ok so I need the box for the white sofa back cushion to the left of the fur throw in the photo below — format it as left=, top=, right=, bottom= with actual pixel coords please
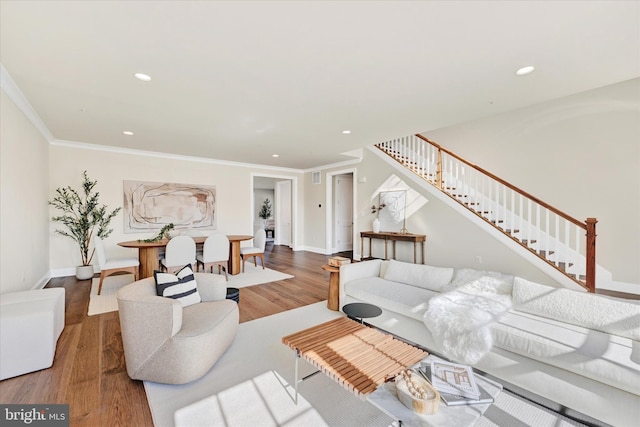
left=384, top=260, right=453, bottom=292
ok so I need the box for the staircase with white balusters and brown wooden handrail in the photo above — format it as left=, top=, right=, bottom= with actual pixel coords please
left=376, top=135, right=610, bottom=292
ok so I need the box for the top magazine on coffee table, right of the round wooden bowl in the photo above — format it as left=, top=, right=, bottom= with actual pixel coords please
left=428, top=360, right=481, bottom=400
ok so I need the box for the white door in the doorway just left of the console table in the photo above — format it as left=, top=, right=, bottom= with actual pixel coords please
left=333, top=174, right=353, bottom=252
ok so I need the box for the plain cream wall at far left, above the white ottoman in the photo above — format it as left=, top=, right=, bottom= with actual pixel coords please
left=0, top=90, right=49, bottom=293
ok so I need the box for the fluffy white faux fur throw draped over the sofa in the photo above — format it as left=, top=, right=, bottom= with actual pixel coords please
left=424, top=276, right=513, bottom=365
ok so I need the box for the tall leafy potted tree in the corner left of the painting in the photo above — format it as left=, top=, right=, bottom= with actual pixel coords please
left=49, top=171, right=121, bottom=280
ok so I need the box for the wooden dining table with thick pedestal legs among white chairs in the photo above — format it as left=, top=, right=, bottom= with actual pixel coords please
left=118, top=234, right=253, bottom=279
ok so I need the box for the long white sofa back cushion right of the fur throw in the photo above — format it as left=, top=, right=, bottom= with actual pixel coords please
left=513, top=277, right=640, bottom=341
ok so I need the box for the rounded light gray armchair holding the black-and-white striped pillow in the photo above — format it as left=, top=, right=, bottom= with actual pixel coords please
left=117, top=273, right=239, bottom=384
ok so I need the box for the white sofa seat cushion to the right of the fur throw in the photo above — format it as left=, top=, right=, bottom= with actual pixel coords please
left=491, top=310, right=640, bottom=395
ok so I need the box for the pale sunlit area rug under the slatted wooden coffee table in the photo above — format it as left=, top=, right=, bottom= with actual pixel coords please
left=144, top=301, right=582, bottom=427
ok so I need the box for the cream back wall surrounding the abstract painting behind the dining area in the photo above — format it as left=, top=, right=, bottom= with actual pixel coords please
left=48, top=144, right=302, bottom=276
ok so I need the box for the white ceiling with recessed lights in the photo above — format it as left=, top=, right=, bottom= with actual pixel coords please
left=0, top=0, right=640, bottom=169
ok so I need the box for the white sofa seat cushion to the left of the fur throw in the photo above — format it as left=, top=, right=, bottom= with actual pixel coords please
left=345, top=277, right=437, bottom=320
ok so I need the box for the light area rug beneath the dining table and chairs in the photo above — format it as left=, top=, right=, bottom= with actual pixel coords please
left=88, top=264, right=293, bottom=316
